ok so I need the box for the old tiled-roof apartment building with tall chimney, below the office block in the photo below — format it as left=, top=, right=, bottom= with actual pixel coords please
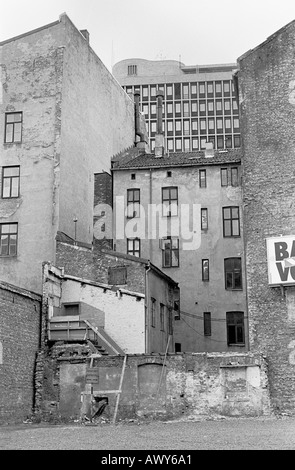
left=112, top=94, right=248, bottom=351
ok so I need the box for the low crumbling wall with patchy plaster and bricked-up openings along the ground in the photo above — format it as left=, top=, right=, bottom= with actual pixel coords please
left=37, top=346, right=271, bottom=420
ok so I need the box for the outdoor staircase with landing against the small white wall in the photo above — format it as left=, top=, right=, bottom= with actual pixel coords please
left=48, top=315, right=125, bottom=356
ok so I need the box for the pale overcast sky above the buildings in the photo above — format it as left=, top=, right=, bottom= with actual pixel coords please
left=0, top=0, right=295, bottom=70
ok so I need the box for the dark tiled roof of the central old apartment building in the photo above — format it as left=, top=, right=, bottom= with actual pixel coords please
left=112, top=149, right=242, bottom=171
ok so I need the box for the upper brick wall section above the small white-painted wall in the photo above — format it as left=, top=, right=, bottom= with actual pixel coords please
left=56, top=242, right=145, bottom=293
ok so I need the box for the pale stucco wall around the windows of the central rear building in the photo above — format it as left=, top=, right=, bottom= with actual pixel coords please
left=113, top=163, right=248, bottom=351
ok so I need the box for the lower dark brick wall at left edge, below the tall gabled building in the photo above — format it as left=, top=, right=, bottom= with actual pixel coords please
left=0, top=282, right=41, bottom=424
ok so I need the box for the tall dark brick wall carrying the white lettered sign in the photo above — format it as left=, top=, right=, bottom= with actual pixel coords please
left=238, top=21, right=295, bottom=414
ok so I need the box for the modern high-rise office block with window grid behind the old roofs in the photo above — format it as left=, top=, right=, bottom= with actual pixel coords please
left=113, top=59, right=240, bottom=152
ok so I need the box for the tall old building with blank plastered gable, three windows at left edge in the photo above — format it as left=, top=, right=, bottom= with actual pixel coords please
left=0, top=14, right=135, bottom=292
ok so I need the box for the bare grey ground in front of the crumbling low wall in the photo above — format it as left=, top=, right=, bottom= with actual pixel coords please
left=0, top=417, right=295, bottom=451
